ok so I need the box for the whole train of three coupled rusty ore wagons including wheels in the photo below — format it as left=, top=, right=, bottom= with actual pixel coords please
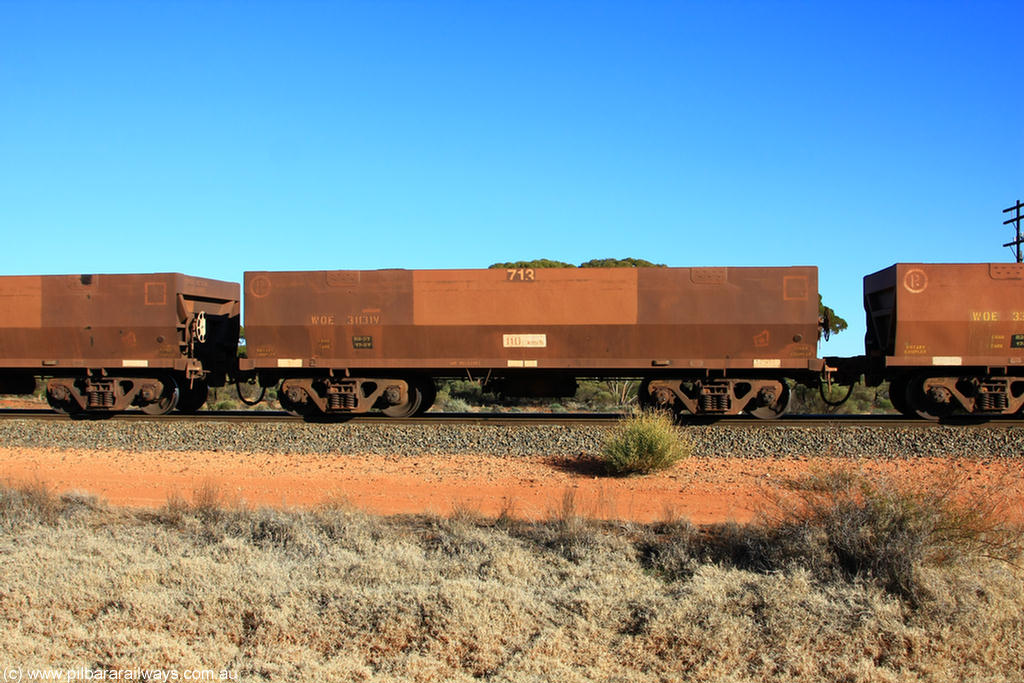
left=0, top=263, right=1024, bottom=419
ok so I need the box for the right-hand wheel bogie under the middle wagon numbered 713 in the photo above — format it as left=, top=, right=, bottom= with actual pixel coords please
left=642, top=378, right=790, bottom=420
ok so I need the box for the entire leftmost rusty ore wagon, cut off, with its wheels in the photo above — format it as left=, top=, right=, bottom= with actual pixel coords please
left=0, top=273, right=240, bottom=415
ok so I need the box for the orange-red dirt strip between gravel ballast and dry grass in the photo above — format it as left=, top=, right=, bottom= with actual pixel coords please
left=0, top=447, right=1024, bottom=523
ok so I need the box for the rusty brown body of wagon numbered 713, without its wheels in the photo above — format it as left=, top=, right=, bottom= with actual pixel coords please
left=245, top=266, right=820, bottom=374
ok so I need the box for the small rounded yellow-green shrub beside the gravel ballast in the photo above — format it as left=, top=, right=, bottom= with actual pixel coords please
left=601, top=411, right=693, bottom=475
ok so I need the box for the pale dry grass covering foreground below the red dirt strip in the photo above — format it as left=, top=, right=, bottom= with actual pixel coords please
left=0, top=473, right=1024, bottom=682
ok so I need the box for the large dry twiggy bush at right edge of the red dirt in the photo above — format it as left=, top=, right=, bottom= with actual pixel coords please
left=762, top=469, right=1022, bottom=604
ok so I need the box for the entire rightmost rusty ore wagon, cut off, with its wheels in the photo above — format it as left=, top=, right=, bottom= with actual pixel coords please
left=864, top=263, right=1024, bottom=418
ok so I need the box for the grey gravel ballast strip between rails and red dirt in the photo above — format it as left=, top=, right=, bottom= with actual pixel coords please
left=0, top=420, right=1024, bottom=458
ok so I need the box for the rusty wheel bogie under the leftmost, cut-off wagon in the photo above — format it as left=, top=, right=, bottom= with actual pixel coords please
left=46, top=372, right=179, bottom=415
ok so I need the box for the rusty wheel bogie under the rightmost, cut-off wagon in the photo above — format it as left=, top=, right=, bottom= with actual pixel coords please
left=906, top=375, right=1024, bottom=418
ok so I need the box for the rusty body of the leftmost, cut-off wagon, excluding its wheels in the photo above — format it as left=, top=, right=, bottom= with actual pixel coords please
left=0, top=273, right=240, bottom=374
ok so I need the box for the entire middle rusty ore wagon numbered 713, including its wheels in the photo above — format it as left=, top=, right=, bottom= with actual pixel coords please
left=242, top=267, right=822, bottom=418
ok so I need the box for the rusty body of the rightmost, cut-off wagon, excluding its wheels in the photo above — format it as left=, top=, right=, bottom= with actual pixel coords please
left=864, top=263, right=1024, bottom=369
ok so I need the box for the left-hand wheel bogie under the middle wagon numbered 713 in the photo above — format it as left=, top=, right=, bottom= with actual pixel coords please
left=278, top=377, right=421, bottom=417
